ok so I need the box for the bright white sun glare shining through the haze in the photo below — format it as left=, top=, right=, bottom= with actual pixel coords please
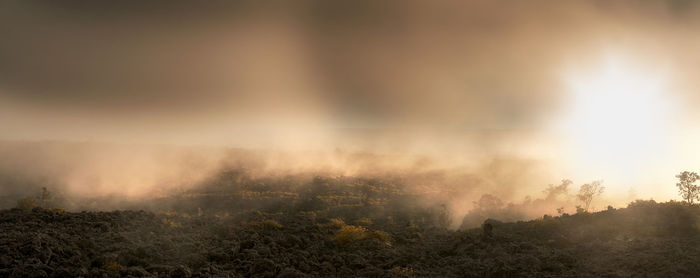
left=563, top=60, right=669, bottom=185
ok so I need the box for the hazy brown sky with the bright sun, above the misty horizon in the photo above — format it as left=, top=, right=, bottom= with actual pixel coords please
left=0, top=0, right=700, bottom=203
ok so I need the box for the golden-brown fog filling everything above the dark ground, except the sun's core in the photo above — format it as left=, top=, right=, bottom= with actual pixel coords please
left=0, top=0, right=700, bottom=213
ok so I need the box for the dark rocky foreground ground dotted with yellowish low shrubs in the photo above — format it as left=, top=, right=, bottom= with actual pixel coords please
left=0, top=204, right=700, bottom=277
